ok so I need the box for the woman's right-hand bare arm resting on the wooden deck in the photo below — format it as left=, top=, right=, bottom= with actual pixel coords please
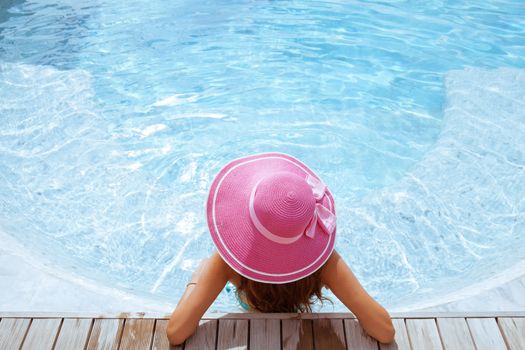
left=321, top=250, right=395, bottom=343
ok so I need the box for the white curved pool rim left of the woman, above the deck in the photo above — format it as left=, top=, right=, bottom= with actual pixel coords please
left=0, top=232, right=171, bottom=313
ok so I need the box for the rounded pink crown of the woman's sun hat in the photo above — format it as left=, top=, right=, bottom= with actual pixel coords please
left=253, top=172, right=315, bottom=238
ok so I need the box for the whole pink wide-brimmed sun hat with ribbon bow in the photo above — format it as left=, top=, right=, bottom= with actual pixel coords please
left=206, top=153, right=336, bottom=283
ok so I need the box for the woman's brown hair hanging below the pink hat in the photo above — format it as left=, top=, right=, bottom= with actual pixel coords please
left=237, top=268, right=331, bottom=312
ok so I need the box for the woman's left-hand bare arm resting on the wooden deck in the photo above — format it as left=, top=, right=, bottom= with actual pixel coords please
left=166, top=252, right=230, bottom=345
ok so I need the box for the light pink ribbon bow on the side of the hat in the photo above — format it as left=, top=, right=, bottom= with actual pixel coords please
left=304, top=175, right=336, bottom=238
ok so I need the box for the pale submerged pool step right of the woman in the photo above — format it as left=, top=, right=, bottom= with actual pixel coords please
left=344, top=68, right=525, bottom=306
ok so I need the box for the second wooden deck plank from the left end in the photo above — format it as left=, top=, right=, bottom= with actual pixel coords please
left=22, top=318, right=62, bottom=350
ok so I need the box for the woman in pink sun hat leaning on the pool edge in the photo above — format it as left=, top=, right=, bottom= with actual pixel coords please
left=167, top=153, right=394, bottom=345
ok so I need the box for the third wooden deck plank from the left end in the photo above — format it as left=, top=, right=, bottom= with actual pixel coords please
left=54, top=318, right=93, bottom=350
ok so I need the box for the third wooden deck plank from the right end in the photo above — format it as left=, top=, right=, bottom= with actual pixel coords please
left=437, top=318, right=476, bottom=350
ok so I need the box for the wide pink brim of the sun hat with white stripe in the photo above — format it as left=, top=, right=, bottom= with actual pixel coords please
left=206, top=153, right=335, bottom=283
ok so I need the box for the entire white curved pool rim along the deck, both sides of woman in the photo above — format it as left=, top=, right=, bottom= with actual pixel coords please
left=0, top=228, right=525, bottom=313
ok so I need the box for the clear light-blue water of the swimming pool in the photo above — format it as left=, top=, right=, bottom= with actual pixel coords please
left=0, top=0, right=525, bottom=309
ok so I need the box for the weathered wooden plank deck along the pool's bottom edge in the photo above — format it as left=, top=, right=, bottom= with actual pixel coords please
left=0, top=312, right=525, bottom=350
